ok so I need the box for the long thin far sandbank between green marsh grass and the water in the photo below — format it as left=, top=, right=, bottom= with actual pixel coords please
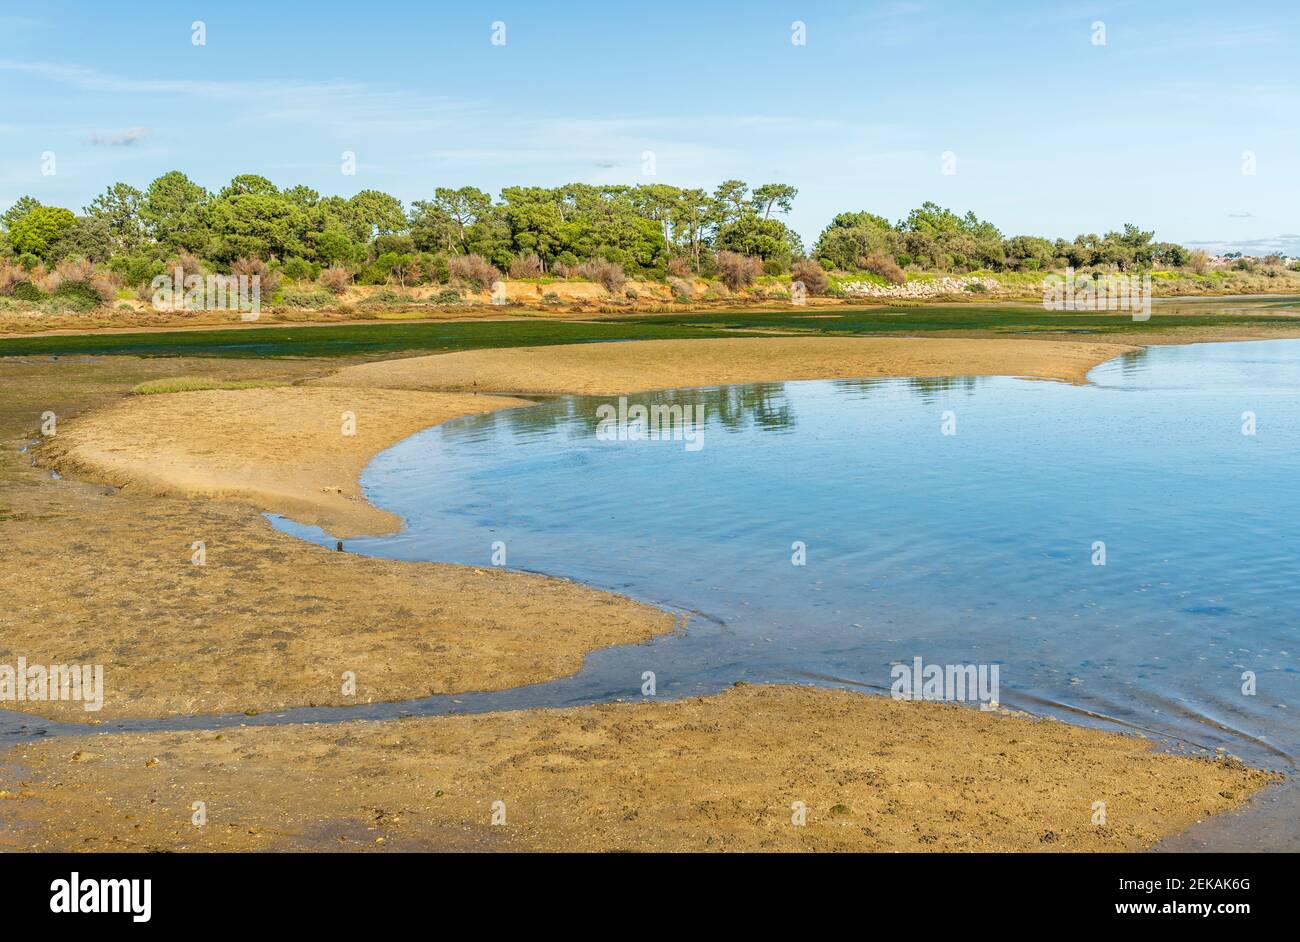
left=316, top=337, right=1136, bottom=395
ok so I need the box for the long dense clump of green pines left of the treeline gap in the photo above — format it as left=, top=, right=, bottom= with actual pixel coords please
left=0, top=172, right=802, bottom=296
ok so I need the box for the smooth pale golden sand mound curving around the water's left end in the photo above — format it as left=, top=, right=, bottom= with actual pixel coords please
left=46, top=386, right=530, bottom=537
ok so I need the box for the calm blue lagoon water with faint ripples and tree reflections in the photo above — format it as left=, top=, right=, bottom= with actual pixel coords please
left=280, top=340, right=1300, bottom=768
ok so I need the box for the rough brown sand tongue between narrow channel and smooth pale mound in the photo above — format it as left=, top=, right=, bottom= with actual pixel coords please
left=0, top=491, right=676, bottom=722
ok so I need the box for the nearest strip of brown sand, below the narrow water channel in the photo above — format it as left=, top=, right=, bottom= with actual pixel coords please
left=0, top=686, right=1269, bottom=851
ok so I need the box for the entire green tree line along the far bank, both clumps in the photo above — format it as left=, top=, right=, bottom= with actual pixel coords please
left=0, top=172, right=1195, bottom=283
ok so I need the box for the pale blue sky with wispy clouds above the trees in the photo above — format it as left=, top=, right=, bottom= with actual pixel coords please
left=0, top=0, right=1300, bottom=253
